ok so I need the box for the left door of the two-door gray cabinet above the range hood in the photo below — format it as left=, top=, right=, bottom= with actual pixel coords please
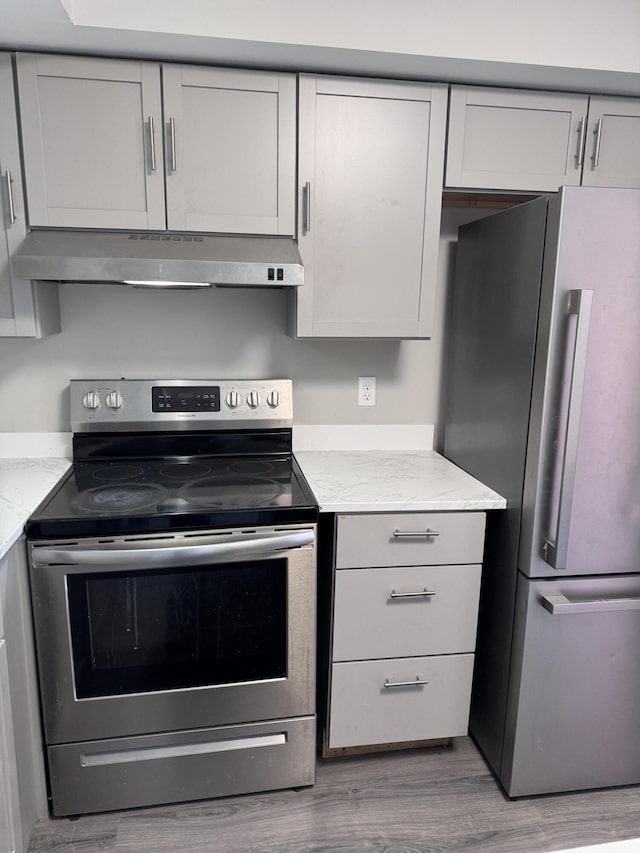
left=17, top=54, right=165, bottom=230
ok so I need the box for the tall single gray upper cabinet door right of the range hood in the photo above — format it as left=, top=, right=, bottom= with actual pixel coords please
left=295, top=75, right=446, bottom=338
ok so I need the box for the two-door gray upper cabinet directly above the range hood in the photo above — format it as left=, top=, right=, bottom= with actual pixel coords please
left=17, top=53, right=296, bottom=235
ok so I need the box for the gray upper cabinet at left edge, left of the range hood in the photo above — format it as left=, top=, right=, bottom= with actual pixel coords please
left=0, top=54, right=60, bottom=338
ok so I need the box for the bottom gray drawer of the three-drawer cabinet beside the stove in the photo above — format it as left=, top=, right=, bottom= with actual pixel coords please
left=329, top=655, right=473, bottom=748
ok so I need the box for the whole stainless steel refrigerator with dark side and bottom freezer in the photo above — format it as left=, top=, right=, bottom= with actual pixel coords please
left=444, top=187, right=640, bottom=797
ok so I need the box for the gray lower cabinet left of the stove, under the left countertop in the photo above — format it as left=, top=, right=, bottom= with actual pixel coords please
left=0, top=540, right=47, bottom=853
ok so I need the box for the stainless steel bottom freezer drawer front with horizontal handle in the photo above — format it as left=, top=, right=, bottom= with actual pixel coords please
left=501, top=575, right=640, bottom=797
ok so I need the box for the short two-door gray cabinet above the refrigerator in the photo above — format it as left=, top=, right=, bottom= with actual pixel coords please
left=445, top=86, right=640, bottom=192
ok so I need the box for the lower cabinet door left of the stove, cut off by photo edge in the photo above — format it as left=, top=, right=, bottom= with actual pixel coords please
left=0, top=640, right=19, bottom=853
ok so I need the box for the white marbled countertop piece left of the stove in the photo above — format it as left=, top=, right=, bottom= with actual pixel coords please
left=0, top=458, right=71, bottom=559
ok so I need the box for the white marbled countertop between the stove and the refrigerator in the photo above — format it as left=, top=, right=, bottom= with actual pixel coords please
left=295, top=450, right=507, bottom=513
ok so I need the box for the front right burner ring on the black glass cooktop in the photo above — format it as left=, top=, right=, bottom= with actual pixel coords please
left=180, top=474, right=284, bottom=510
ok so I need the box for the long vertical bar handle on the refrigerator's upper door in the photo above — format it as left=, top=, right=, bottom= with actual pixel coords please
left=543, top=290, right=593, bottom=570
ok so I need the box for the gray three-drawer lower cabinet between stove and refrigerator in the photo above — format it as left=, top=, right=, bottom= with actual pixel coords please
left=326, top=512, right=485, bottom=749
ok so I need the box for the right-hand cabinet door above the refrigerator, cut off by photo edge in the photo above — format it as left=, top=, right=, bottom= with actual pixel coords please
left=582, top=98, right=640, bottom=187
